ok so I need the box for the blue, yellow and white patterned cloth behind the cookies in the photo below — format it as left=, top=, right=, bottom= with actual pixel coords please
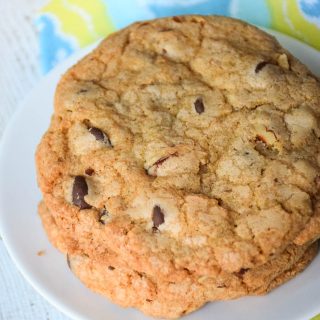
left=36, top=0, right=320, bottom=72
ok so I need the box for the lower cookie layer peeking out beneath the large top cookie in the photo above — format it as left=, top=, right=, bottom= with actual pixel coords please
left=39, top=203, right=317, bottom=318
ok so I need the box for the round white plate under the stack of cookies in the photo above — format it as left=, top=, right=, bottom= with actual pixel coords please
left=0, top=31, right=320, bottom=320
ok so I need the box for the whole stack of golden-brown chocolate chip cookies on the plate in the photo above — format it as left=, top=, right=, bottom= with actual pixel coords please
left=36, top=16, right=320, bottom=318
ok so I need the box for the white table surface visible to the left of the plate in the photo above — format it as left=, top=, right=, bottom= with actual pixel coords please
left=0, top=0, right=68, bottom=320
